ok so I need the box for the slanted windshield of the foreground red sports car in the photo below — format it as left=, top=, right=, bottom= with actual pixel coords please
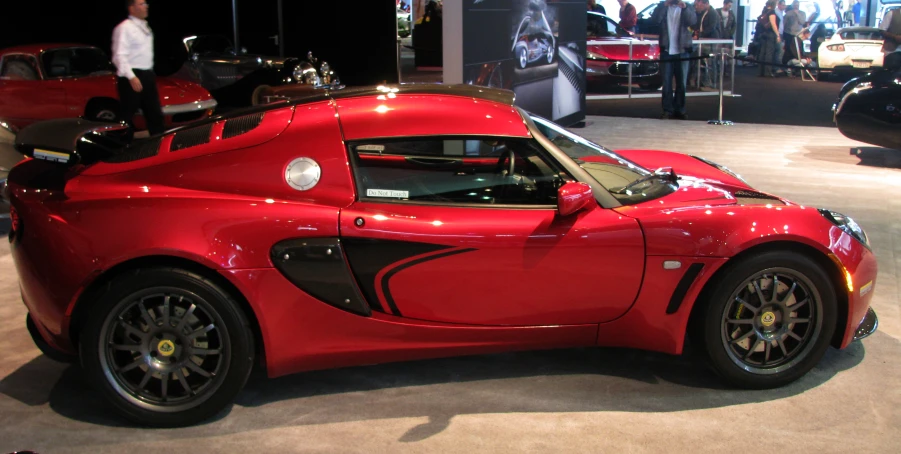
left=531, top=116, right=676, bottom=205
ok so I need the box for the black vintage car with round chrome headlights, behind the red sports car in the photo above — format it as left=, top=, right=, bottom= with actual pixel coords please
left=172, top=35, right=343, bottom=108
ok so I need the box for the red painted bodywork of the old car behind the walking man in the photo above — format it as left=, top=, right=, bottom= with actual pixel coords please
left=0, top=43, right=213, bottom=129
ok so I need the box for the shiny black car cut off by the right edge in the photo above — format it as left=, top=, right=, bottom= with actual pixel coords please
left=833, top=63, right=901, bottom=151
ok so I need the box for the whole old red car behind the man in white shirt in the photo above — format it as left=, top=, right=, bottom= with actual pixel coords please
left=0, top=44, right=216, bottom=128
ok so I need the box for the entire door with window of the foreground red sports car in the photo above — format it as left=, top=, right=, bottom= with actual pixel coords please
left=340, top=137, right=644, bottom=325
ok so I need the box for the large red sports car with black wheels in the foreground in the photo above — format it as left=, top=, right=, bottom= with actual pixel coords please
left=7, top=85, right=877, bottom=425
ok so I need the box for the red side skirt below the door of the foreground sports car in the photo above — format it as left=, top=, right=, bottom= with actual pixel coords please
left=223, top=269, right=598, bottom=377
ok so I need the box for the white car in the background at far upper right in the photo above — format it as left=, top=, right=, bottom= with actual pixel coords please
left=817, top=27, right=882, bottom=76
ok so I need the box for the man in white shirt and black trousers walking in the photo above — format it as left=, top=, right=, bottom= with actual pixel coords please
left=113, top=0, right=165, bottom=141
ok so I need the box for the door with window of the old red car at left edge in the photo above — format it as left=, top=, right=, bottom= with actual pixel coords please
left=0, top=54, right=67, bottom=126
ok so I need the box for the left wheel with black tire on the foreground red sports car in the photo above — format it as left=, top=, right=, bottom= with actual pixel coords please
left=79, top=268, right=254, bottom=427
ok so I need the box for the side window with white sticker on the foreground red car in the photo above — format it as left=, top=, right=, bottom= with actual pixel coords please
left=348, top=137, right=568, bottom=205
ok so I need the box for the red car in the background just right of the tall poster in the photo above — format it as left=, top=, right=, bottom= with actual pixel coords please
left=585, top=11, right=663, bottom=91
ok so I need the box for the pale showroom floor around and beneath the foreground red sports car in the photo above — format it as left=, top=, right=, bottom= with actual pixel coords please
left=0, top=117, right=901, bottom=453
